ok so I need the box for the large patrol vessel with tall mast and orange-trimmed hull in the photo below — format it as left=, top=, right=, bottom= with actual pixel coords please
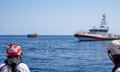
left=74, top=14, right=120, bottom=41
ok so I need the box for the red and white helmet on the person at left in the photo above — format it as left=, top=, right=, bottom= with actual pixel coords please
left=7, top=44, right=22, bottom=56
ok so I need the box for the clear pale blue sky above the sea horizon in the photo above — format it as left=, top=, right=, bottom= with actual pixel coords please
left=0, top=0, right=120, bottom=35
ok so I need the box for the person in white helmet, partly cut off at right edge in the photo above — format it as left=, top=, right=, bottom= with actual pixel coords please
left=107, top=40, right=120, bottom=72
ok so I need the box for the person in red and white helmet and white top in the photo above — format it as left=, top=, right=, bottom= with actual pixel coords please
left=0, top=44, right=30, bottom=72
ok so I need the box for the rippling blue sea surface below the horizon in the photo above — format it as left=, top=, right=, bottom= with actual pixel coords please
left=0, top=35, right=113, bottom=72
